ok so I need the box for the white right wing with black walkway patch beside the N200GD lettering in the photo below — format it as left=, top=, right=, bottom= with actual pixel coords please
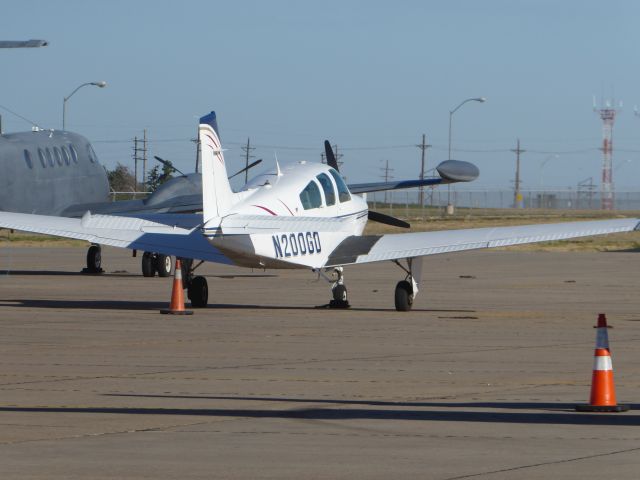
left=325, top=218, right=640, bottom=267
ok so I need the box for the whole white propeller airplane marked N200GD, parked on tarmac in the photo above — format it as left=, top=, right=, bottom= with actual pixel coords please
left=0, top=111, right=640, bottom=311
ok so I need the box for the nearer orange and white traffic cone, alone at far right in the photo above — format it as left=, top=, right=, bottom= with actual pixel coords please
left=576, top=313, right=629, bottom=412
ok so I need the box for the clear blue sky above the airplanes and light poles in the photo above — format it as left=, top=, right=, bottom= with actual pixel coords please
left=0, top=0, right=640, bottom=189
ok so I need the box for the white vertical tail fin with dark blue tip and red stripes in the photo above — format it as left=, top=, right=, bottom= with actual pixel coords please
left=198, top=112, right=233, bottom=223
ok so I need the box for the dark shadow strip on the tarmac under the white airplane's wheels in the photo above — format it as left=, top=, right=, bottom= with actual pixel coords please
left=0, top=298, right=475, bottom=318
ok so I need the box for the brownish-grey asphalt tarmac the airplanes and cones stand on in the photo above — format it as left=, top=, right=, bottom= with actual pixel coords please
left=0, top=247, right=640, bottom=480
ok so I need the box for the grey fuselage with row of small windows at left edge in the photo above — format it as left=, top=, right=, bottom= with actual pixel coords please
left=0, top=130, right=109, bottom=215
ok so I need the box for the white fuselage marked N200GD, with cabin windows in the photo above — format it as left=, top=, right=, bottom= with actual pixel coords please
left=205, top=162, right=368, bottom=268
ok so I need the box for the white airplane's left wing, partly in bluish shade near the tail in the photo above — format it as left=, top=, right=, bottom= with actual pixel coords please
left=0, top=212, right=231, bottom=264
